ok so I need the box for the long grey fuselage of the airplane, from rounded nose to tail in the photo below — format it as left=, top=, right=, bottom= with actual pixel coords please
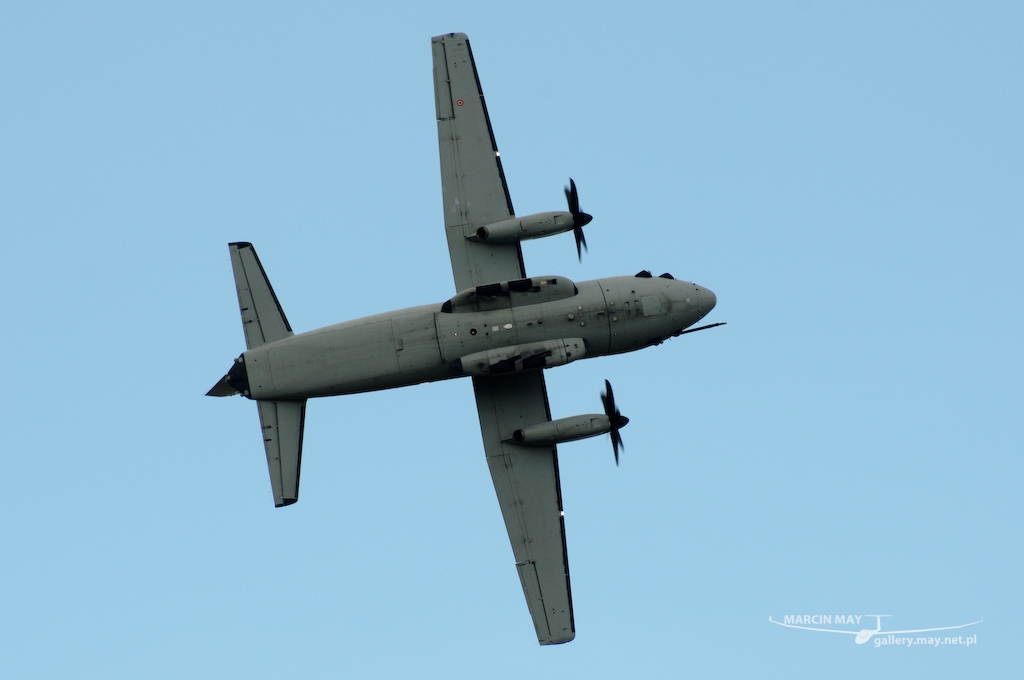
left=242, top=277, right=716, bottom=400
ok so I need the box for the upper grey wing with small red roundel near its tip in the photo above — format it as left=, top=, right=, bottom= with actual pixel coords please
left=431, top=33, right=526, bottom=292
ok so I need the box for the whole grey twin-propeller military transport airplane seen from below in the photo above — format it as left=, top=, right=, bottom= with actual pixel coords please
left=209, top=33, right=720, bottom=644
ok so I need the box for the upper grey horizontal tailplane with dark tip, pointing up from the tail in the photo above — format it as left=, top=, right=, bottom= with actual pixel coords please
left=227, top=242, right=295, bottom=349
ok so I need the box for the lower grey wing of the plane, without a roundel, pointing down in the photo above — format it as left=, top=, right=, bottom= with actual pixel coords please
left=473, top=371, right=575, bottom=644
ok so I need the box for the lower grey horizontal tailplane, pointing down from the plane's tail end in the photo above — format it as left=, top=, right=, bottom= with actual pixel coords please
left=256, top=399, right=306, bottom=508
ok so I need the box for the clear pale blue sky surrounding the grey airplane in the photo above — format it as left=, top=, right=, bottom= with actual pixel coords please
left=0, top=0, right=1024, bottom=678
